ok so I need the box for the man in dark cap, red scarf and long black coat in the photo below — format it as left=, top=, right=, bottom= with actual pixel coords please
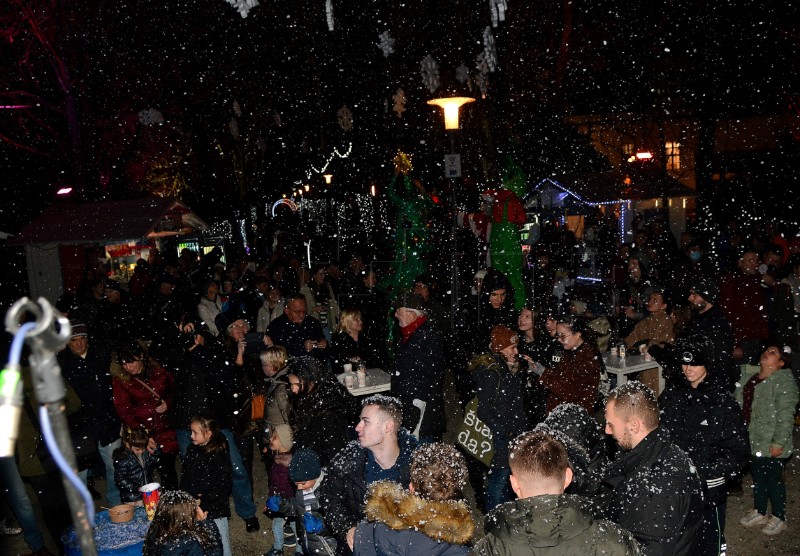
left=392, top=293, right=447, bottom=442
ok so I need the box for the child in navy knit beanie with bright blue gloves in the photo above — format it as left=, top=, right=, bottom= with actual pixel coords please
left=267, top=448, right=336, bottom=555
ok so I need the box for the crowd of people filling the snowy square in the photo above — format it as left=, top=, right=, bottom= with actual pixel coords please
left=0, top=216, right=800, bottom=556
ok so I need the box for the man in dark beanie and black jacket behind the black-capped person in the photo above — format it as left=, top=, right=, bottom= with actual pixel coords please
left=683, top=276, right=739, bottom=392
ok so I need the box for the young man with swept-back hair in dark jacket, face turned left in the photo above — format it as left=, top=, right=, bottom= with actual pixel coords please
left=320, top=394, right=417, bottom=552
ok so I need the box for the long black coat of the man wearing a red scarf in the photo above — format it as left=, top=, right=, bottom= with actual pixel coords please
left=392, top=320, right=447, bottom=438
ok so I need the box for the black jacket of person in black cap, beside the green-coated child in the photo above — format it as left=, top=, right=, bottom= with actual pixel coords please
left=658, top=379, right=750, bottom=506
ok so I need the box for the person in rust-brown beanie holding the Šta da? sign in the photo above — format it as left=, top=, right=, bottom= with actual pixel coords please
left=470, top=325, right=528, bottom=512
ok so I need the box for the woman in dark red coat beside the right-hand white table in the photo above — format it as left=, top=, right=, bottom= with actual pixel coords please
left=541, top=317, right=603, bottom=415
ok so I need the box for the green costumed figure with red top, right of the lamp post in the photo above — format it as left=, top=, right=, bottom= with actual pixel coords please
left=484, top=157, right=527, bottom=310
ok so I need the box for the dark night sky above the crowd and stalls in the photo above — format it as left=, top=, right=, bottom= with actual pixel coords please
left=0, top=0, right=800, bottom=233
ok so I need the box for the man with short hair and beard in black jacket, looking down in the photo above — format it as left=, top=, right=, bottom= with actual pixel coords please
left=604, top=382, right=703, bottom=556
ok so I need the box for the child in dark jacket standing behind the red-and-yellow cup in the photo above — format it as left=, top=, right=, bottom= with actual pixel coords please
left=113, top=427, right=161, bottom=506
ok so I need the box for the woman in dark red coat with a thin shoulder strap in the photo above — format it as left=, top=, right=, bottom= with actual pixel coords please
left=112, top=343, right=178, bottom=489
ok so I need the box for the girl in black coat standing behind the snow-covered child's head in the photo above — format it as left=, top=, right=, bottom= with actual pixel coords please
left=181, top=415, right=232, bottom=556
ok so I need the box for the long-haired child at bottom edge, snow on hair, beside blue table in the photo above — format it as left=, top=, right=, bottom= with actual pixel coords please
left=142, top=490, right=222, bottom=556
